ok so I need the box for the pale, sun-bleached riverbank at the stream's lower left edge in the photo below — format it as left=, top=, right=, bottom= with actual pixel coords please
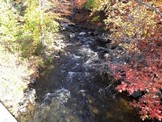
left=0, top=49, right=34, bottom=116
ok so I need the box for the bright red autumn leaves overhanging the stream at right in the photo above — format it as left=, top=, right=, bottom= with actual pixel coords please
left=110, top=35, right=162, bottom=121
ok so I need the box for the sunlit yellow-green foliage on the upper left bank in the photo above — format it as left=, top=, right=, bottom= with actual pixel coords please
left=0, top=0, right=59, bottom=57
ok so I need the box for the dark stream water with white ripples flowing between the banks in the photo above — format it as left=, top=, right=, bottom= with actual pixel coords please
left=18, top=24, right=141, bottom=122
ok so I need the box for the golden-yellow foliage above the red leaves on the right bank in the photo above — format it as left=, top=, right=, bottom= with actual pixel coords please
left=90, top=0, right=156, bottom=49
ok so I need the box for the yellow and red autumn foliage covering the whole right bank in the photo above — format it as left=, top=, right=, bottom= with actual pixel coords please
left=83, top=0, right=162, bottom=121
